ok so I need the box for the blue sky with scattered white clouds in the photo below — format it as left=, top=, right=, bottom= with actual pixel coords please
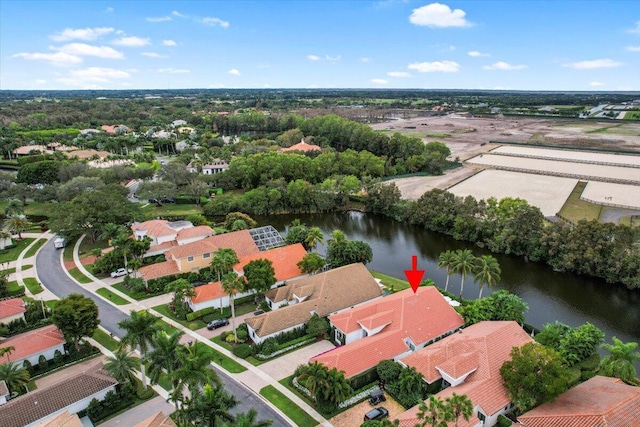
left=0, top=0, right=640, bottom=91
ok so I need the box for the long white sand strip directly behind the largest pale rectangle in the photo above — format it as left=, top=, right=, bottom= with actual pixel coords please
left=467, top=154, right=640, bottom=184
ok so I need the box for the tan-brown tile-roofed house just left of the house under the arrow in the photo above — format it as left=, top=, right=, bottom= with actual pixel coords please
left=246, top=263, right=382, bottom=343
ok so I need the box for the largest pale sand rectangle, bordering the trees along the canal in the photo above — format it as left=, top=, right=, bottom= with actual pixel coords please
left=449, top=170, right=578, bottom=216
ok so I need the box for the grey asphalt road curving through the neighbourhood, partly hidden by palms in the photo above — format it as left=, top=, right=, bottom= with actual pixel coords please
left=35, top=239, right=290, bottom=427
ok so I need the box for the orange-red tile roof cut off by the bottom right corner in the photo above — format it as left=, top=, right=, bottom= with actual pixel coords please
left=518, top=376, right=640, bottom=427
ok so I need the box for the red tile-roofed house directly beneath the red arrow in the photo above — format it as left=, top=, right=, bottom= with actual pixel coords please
left=310, top=286, right=464, bottom=378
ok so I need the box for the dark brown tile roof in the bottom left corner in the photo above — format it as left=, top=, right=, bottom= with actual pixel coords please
left=0, top=363, right=118, bottom=427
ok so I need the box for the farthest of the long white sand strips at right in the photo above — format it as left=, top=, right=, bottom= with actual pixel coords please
left=491, top=145, right=640, bottom=167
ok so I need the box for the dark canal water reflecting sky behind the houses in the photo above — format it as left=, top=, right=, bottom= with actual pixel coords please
left=256, top=212, right=640, bottom=352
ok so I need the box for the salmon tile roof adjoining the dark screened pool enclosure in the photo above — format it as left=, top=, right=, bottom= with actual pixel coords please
left=166, top=230, right=260, bottom=259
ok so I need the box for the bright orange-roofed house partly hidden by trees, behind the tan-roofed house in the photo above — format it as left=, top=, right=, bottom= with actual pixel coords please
left=188, top=243, right=307, bottom=311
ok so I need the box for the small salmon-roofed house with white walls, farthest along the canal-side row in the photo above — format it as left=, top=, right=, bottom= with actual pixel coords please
left=131, top=219, right=215, bottom=257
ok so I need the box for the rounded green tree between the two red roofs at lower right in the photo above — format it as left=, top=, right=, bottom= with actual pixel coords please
left=500, top=343, right=570, bottom=412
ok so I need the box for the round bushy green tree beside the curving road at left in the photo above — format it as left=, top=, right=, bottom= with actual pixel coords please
left=51, top=293, right=100, bottom=350
